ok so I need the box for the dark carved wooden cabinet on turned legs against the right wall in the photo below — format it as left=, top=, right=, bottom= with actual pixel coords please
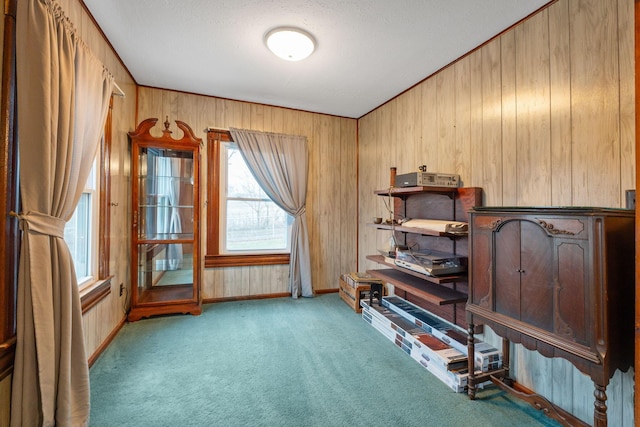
left=467, top=207, right=635, bottom=426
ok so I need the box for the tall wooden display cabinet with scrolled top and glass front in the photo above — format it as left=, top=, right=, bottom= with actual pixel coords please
left=128, top=118, right=202, bottom=321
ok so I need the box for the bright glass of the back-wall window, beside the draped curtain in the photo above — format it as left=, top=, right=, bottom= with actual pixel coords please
left=220, top=143, right=293, bottom=253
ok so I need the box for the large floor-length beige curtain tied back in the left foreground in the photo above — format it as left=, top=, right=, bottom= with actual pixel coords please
left=11, top=0, right=113, bottom=426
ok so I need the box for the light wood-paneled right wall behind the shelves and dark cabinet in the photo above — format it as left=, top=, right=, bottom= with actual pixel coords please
left=358, top=0, right=635, bottom=426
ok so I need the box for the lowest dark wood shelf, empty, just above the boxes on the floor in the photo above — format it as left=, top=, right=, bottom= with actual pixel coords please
left=367, top=268, right=467, bottom=305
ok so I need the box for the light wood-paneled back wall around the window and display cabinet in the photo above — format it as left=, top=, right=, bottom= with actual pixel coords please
left=137, top=87, right=357, bottom=302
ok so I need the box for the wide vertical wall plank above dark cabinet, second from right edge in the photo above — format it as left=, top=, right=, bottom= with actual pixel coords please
left=569, top=0, right=621, bottom=206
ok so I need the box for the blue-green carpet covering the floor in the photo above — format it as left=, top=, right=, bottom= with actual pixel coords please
left=90, top=294, right=558, bottom=427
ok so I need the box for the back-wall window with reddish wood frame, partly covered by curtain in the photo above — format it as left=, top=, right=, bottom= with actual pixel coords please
left=205, top=130, right=293, bottom=267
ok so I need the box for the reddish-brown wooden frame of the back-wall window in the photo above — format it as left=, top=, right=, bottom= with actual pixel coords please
left=204, top=128, right=290, bottom=268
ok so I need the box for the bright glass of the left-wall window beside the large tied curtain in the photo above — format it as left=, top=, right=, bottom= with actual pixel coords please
left=64, top=193, right=91, bottom=283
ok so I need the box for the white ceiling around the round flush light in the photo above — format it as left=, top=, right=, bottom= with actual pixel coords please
left=84, top=0, right=549, bottom=118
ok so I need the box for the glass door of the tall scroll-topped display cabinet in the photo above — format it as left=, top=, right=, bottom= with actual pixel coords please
left=137, top=147, right=194, bottom=303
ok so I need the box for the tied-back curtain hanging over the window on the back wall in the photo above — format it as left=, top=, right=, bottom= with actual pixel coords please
left=229, top=128, right=313, bottom=298
